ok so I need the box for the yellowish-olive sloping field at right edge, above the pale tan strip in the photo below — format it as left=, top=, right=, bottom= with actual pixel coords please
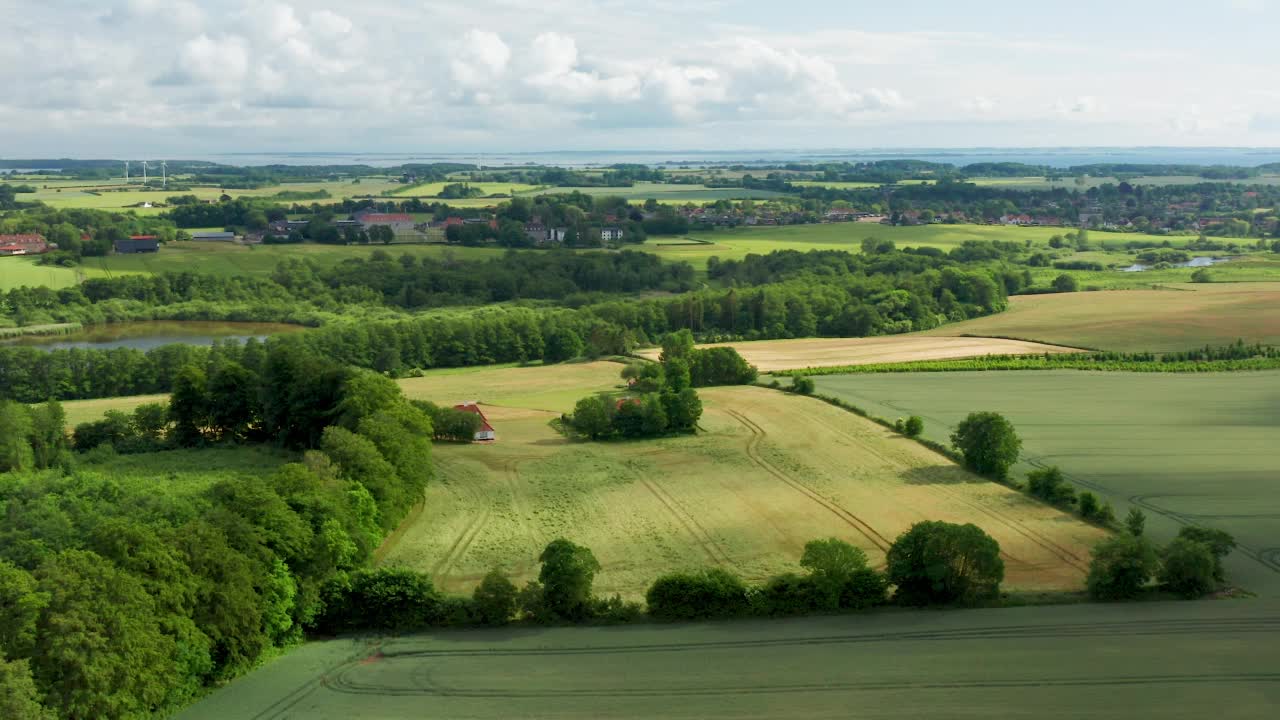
left=925, top=282, right=1280, bottom=352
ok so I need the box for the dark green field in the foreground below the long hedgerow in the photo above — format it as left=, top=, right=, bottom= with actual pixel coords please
left=178, top=601, right=1280, bottom=720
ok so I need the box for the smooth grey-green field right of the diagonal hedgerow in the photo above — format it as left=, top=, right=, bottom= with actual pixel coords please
left=815, top=370, right=1280, bottom=596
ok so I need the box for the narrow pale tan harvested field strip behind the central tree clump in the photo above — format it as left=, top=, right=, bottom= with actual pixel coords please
left=636, top=335, right=1075, bottom=373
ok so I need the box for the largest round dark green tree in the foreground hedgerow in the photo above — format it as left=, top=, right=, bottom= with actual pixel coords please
left=887, top=521, right=1005, bottom=605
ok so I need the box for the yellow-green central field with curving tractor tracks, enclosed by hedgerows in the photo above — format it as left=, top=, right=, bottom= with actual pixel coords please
left=379, top=384, right=1105, bottom=598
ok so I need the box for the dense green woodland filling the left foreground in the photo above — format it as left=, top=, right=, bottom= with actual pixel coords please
left=0, top=347, right=431, bottom=717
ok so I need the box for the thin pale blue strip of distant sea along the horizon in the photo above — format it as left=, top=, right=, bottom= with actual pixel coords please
left=202, top=147, right=1280, bottom=168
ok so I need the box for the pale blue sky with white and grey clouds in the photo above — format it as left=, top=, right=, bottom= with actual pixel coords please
left=0, top=0, right=1280, bottom=158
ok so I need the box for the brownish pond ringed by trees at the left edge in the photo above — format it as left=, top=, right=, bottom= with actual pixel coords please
left=0, top=320, right=306, bottom=351
